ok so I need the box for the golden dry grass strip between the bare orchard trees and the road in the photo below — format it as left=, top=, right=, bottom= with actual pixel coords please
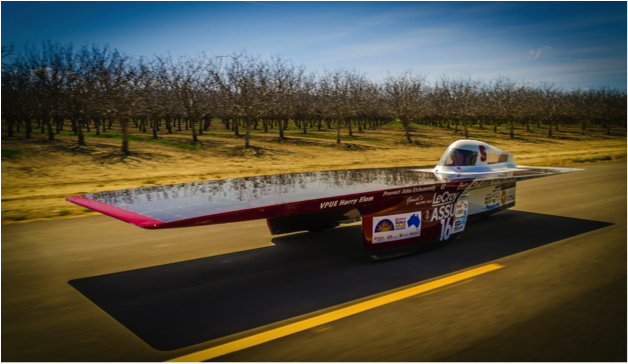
left=2, top=122, right=628, bottom=224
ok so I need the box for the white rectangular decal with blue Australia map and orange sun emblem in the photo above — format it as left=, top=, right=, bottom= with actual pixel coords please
left=373, top=212, right=421, bottom=244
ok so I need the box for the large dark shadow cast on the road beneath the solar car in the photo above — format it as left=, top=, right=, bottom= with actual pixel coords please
left=69, top=211, right=612, bottom=350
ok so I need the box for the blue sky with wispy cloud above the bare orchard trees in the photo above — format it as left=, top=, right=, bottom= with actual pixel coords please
left=1, top=1, right=628, bottom=91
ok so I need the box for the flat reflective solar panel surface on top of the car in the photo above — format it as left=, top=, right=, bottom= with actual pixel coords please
left=77, top=167, right=576, bottom=223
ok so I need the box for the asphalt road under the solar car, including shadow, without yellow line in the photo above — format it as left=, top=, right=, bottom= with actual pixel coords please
left=1, top=162, right=628, bottom=362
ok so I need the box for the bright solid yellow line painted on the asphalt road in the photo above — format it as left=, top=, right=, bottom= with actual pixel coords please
left=165, top=264, right=504, bottom=363
